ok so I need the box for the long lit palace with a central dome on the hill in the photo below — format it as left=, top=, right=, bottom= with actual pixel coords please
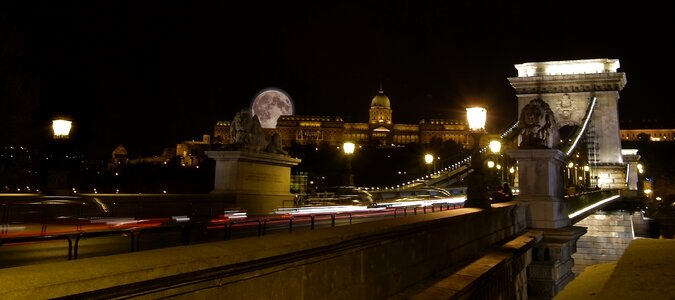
left=214, top=89, right=471, bottom=146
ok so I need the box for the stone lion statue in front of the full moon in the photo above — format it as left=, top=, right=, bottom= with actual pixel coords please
left=230, top=108, right=288, bottom=154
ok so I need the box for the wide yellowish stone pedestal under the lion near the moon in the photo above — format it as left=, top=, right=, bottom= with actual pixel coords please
left=205, top=151, right=300, bottom=215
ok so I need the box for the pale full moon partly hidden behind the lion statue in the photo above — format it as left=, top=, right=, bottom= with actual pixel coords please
left=251, top=89, right=293, bottom=128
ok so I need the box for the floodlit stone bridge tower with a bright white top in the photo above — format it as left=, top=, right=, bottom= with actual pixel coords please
left=508, top=58, right=626, bottom=188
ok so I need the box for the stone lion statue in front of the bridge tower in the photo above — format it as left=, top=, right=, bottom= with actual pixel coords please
left=518, top=98, right=560, bottom=149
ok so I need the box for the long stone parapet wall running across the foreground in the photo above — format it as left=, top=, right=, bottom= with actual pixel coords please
left=0, top=203, right=529, bottom=300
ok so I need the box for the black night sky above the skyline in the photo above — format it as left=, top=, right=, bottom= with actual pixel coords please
left=0, top=0, right=675, bottom=157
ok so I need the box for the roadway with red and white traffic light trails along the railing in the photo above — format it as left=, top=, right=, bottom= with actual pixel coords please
left=0, top=197, right=464, bottom=268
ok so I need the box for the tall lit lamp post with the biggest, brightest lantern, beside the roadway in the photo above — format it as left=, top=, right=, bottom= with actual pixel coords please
left=464, top=107, right=490, bottom=209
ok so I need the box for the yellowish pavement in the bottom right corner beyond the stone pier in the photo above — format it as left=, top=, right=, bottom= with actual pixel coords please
left=553, top=238, right=675, bottom=300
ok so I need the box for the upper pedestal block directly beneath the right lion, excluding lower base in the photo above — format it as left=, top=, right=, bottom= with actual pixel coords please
left=508, top=149, right=571, bottom=229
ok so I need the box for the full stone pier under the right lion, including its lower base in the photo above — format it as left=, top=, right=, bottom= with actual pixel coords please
left=508, top=149, right=586, bottom=299
